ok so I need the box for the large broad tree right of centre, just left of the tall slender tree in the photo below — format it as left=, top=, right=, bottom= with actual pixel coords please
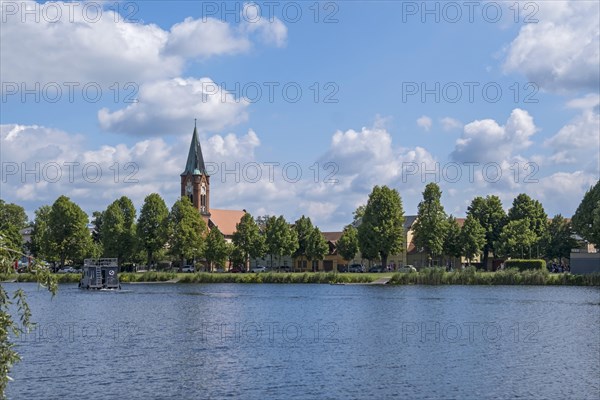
left=358, top=186, right=404, bottom=266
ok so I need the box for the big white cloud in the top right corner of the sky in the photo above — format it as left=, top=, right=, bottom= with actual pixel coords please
left=504, top=1, right=600, bottom=92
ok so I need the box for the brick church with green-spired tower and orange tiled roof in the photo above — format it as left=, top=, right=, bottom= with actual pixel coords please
left=181, top=126, right=246, bottom=242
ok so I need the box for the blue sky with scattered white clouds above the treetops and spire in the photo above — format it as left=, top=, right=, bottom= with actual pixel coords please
left=0, top=0, right=600, bottom=231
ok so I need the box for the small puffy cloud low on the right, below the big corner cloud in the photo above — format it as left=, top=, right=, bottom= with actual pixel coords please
left=450, top=108, right=537, bottom=163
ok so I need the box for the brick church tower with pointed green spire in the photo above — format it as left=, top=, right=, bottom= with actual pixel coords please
left=181, top=123, right=210, bottom=221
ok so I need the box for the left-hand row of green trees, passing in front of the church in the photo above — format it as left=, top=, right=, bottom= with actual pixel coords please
left=0, top=193, right=329, bottom=269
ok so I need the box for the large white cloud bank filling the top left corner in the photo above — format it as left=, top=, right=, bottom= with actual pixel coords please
left=0, top=1, right=287, bottom=86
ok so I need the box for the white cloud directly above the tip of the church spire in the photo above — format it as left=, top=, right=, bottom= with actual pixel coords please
left=98, top=78, right=249, bottom=135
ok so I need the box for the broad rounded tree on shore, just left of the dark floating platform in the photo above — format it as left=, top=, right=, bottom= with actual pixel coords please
left=46, top=196, right=92, bottom=266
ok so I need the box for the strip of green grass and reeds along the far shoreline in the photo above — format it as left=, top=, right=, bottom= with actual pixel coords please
left=0, top=268, right=600, bottom=286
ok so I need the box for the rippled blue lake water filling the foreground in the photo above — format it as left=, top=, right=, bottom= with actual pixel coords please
left=5, top=284, right=600, bottom=399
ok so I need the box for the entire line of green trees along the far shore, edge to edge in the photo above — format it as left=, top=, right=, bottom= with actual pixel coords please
left=0, top=183, right=600, bottom=266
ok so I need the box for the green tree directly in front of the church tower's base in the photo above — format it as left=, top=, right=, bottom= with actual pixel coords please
left=168, top=196, right=207, bottom=266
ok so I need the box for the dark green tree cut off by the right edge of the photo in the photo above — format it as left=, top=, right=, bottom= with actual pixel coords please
left=572, top=181, right=600, bottom=247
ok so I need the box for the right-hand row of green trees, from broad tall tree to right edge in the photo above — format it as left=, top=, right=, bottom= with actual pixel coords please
left=338, top=183, right=600, bottom=266
